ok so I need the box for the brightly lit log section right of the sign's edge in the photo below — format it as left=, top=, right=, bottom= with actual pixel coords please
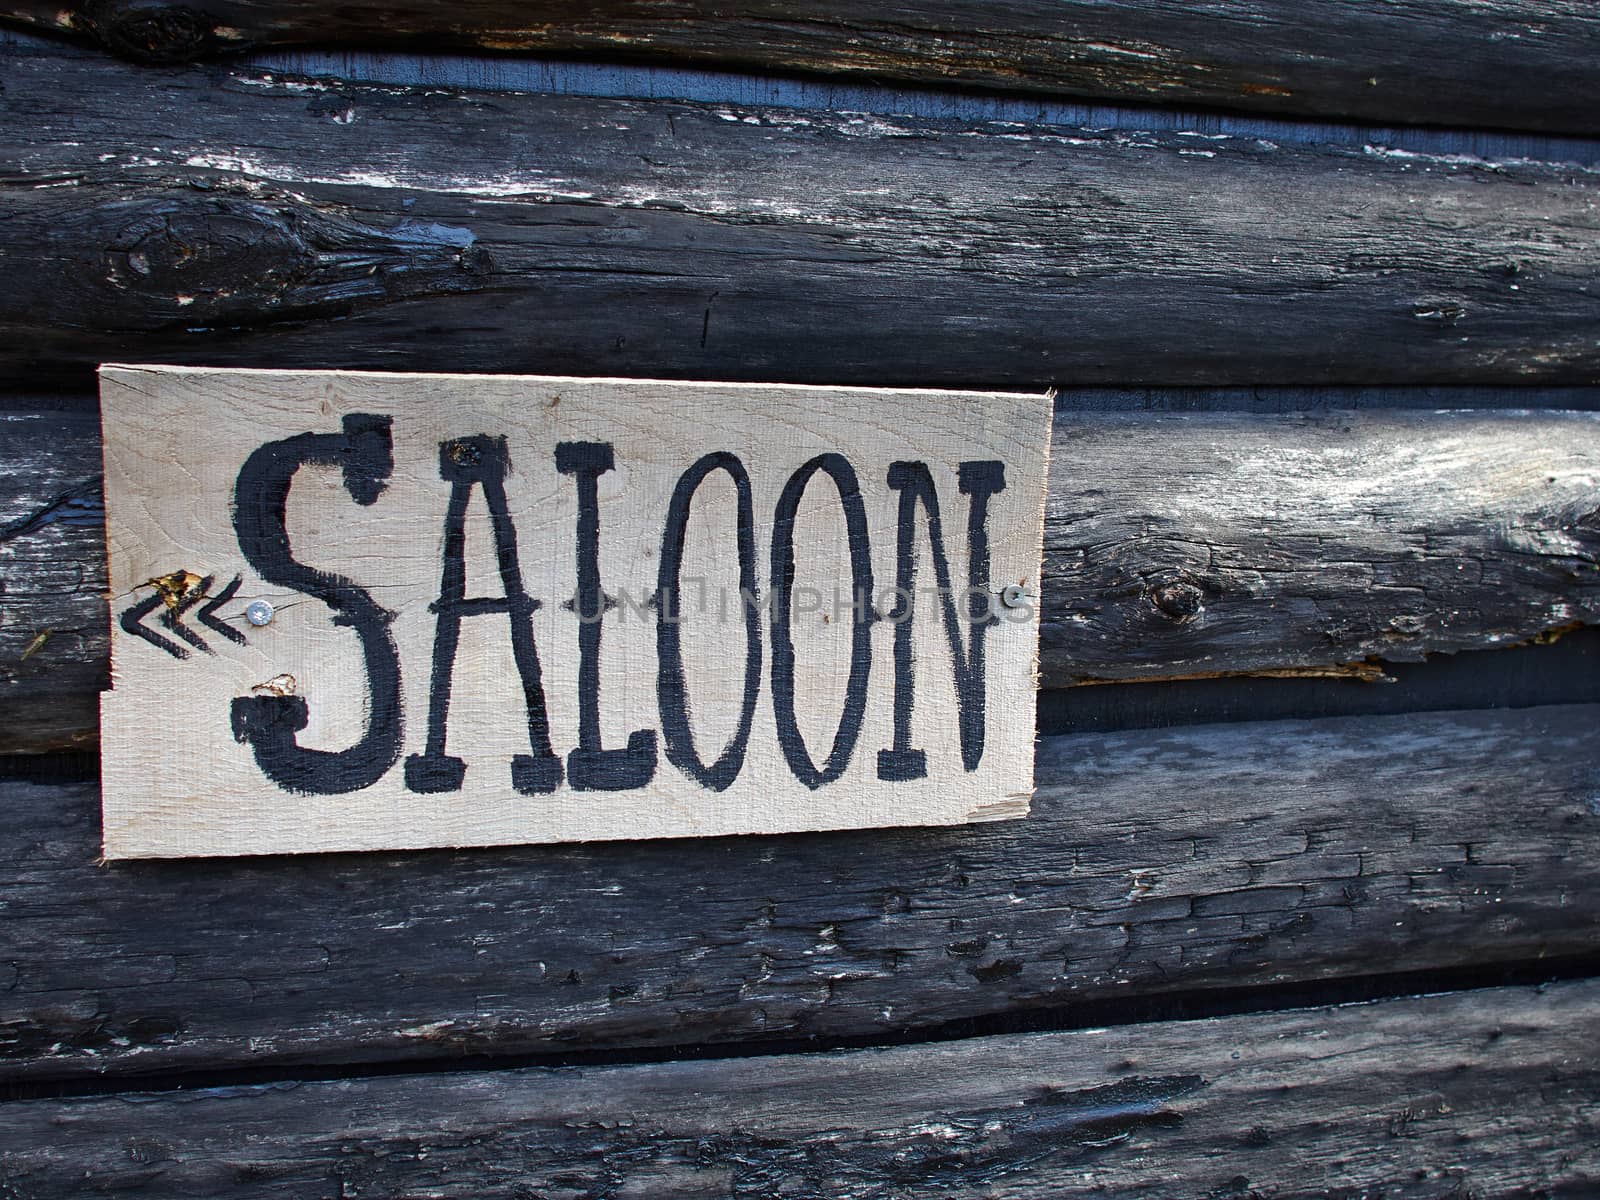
left=1040, top=413, right=1600, bottom=686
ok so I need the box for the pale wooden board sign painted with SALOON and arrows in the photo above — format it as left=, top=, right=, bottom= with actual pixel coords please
left=101, top=366, right=1050, bottom=858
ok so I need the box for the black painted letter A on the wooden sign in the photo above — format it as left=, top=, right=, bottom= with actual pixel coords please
left=405, top=434, right=562, bottom=795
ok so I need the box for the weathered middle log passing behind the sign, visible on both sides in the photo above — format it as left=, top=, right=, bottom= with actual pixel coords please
left=0, top=412, right=1600, bottom=754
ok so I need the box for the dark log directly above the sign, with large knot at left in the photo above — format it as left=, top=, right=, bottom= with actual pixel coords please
left=0, top=43, right=1600, bottom=390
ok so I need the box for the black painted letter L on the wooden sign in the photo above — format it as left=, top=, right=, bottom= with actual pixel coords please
left=555, top=442, right=656, bottom=792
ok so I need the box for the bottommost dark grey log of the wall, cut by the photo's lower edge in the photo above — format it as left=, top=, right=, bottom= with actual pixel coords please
left=0, top=982, right=1600, bottom=1200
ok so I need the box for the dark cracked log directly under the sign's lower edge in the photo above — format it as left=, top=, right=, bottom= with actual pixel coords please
left=0, top=706, right=1600, bottom=1078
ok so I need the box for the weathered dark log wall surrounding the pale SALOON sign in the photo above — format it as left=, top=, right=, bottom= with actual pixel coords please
left=0, top=14, right=1600, bottom=1197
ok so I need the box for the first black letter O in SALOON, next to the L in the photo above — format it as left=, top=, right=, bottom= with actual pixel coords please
left=656, top=451, right=762, bottom=792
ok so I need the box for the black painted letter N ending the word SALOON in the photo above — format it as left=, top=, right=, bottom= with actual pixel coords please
left=878, top=462, right=1005, bottom=781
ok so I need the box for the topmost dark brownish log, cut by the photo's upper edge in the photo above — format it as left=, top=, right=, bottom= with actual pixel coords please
left=0, top=0, right=1600, bottom=131
